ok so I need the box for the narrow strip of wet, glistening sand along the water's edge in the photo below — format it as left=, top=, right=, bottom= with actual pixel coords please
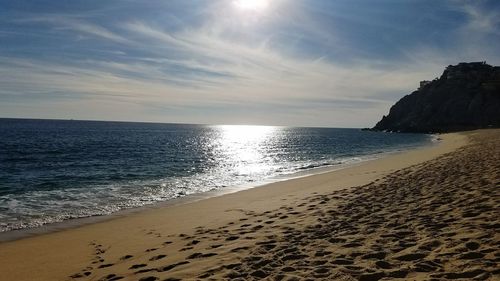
left=0, top=134, right=441, bottom=241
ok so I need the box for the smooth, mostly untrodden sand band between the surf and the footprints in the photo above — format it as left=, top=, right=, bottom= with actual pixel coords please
left=0, top=130, right=470, bottom=280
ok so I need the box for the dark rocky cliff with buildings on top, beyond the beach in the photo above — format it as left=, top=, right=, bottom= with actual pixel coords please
left=373, top=62, right=500, bottom=133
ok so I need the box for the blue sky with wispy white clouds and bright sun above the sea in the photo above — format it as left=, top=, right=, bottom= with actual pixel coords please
left=0, top=0, right=500, bottom=128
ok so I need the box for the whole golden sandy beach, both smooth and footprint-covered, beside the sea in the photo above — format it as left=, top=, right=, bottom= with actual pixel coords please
left=0, top=130, right=500, bottom=280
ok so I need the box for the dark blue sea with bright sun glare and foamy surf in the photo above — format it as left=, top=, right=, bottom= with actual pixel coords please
left=0, top=119, right=431, bottom=231
